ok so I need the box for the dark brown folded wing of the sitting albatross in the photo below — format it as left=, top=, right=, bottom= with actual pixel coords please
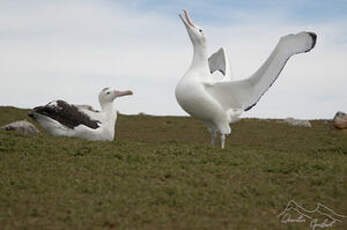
left=34, top=100, right=101, bottom=129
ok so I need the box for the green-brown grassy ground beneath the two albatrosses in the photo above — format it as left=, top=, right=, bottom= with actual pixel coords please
left=0, top=107, right=347, bottom=230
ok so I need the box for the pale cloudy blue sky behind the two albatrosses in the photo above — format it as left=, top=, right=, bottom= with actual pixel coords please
left=0, top=0, right=347, bottom=118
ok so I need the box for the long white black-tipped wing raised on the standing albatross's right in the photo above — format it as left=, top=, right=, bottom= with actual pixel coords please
left=205, top=32, right=316, bottom=111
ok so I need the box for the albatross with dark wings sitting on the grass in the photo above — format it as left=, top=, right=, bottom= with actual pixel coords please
left=29, top=88, right=133, bottom=141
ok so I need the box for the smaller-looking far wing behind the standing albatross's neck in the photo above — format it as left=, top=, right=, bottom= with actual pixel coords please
left=208, top=48, right=231, bottom=79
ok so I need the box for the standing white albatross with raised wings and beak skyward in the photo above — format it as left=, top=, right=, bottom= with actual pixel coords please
left=175, top=10, right=317, bottom=148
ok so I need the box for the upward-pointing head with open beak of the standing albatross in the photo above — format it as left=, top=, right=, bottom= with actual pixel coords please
left=179, top=10, right=206, bottom=47
